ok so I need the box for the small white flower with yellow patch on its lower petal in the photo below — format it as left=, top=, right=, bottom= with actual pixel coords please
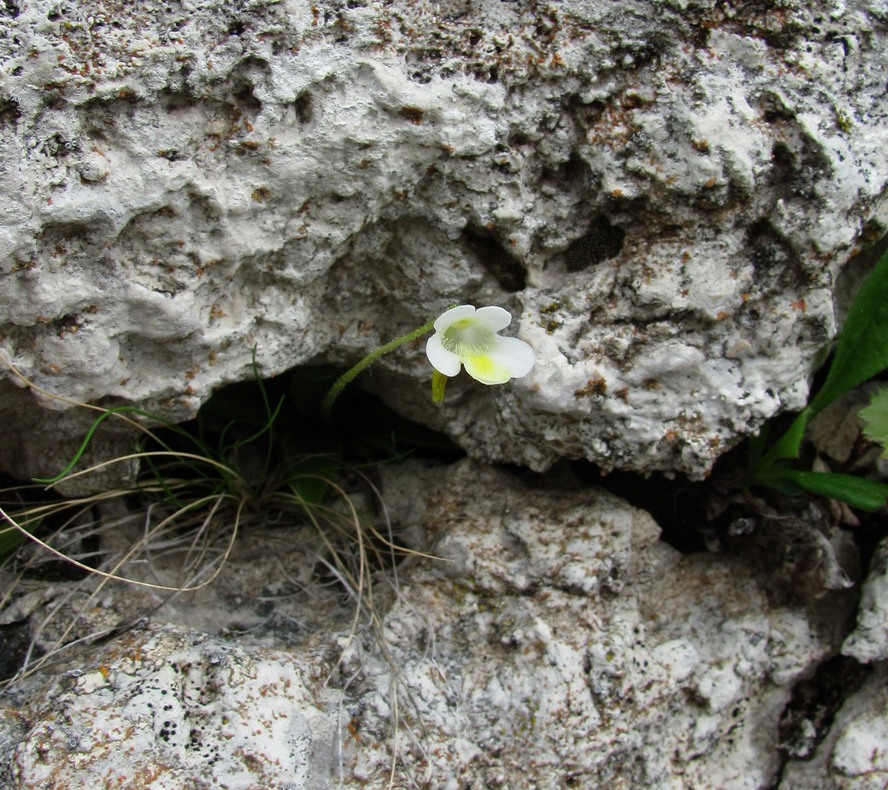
left=426, top=304, right=536, bottom=384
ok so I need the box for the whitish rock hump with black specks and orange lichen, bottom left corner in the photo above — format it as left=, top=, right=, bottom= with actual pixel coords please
left=0, top=627, right=335, bottom=790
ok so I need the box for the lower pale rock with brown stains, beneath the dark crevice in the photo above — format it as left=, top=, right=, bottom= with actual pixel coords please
left=0, top=462, right=864, bottom=790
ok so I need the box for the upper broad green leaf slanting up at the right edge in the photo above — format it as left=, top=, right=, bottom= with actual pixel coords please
left=807, top=252, right=888, bottom=416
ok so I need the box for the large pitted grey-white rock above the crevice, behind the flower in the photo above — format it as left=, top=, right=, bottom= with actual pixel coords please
left=0, top=0, right=888, bottom=475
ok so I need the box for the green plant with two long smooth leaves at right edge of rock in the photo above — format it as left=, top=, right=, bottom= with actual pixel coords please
left=746, top=244, right=888, bottom=511
